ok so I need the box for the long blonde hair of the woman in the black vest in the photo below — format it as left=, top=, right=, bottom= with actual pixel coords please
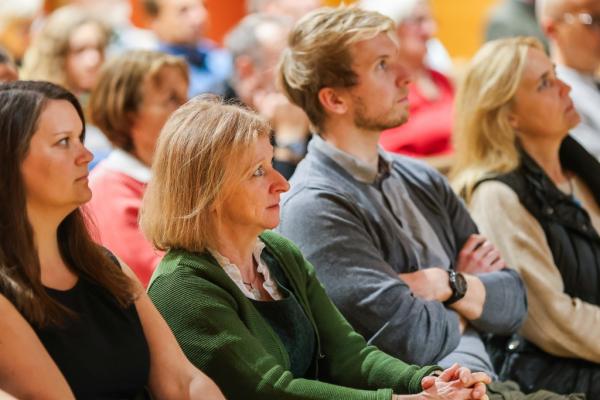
left=450, top=37, right=544, bottom=202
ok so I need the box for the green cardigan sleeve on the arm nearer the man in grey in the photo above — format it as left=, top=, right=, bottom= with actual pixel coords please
left=290, top=243, right=440, bottom=394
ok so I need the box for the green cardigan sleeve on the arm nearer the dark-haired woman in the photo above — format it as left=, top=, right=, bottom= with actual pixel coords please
left=148, top=268, right=398, bottom=400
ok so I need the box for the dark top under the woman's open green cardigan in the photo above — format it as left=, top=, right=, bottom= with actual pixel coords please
left=251, top=250, right=317, bottom=378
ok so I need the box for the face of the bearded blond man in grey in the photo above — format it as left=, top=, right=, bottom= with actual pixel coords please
left=348, top=33, right=409, bottom=133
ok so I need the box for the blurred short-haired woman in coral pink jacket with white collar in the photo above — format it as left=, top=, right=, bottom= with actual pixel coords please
left=89, top=50, right=188, bottom=286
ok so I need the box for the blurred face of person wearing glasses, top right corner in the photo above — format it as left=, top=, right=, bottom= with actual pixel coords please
left=551, top=0, right=600, bottom=73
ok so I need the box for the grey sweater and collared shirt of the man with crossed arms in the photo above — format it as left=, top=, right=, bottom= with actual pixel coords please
left=278, top=136, right=527, bottom=376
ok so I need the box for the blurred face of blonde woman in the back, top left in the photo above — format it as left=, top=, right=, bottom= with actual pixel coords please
left=66, top=22, right=104, bottom=92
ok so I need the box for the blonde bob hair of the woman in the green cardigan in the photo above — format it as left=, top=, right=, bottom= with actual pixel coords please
left=140, top=95, right=271, bottom=252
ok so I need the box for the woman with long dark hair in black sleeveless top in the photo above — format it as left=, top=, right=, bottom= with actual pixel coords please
left=0, top=81, right=223, bottom=399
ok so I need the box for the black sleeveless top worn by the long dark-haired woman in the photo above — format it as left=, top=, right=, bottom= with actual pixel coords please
left=33, top=277, right=150, bottom=399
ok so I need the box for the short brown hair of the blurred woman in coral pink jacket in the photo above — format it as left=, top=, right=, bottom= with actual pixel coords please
left=87, top=50, right=189, bottom=152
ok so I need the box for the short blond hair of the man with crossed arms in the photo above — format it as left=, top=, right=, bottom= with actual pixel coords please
left=279, top=6, right=394, bottom=132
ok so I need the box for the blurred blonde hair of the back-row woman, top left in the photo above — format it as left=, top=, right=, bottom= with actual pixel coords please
left=21, top=5, right=110, bottom=90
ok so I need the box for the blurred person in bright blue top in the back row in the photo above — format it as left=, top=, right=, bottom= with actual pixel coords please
left=142, top=0, right=232, bottom=97
